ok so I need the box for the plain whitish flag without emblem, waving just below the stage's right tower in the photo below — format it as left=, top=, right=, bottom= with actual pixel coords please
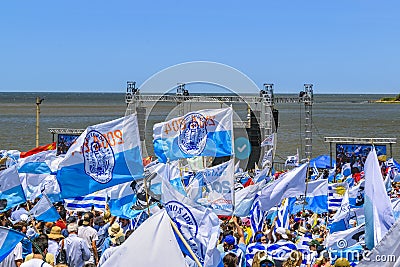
left=259, top=163, right=308, bottom=211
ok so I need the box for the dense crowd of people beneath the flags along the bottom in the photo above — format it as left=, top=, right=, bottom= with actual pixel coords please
left=0, top=199, right=350, bottom=267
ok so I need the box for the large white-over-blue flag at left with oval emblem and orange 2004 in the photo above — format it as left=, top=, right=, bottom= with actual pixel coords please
left=57, top=114, right=143, bottom=198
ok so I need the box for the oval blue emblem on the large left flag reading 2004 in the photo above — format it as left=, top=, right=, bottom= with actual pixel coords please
left=82, top=130, right=115, bottom=184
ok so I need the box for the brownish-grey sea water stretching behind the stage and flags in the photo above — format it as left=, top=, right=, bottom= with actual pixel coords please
left=0, top=92, right=400, bottom=161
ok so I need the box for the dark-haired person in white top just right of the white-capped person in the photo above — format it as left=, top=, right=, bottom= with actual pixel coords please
left=78, top=212, right=99, bottom=265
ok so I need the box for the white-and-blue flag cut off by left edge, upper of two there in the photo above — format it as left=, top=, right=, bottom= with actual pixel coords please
left=0, top=166, right=26, bottom=212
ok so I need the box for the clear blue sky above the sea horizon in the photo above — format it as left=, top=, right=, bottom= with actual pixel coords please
left=0, top=0, right=400, bottom=94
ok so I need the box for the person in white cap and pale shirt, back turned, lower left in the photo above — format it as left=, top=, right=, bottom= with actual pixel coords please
left=61, top=223, right=91, bottom=267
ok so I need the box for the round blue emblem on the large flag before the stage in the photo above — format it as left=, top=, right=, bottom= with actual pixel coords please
left=178, top=113, right=207, bottom=156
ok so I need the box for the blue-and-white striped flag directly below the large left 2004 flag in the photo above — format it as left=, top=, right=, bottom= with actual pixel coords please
left=64, top=190, right=107, bottom=212
